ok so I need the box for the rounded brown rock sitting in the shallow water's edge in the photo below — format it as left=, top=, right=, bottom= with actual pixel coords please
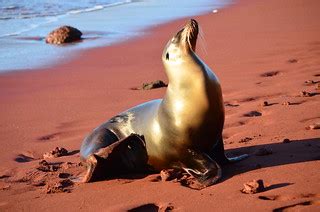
left=46, top=26, right=82, bottom=44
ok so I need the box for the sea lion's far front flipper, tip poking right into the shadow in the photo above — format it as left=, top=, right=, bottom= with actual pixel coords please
left=208, top=137, right=249, bottom=165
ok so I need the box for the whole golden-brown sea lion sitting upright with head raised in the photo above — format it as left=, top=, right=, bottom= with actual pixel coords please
left=80, top=19, right=247, bottom=188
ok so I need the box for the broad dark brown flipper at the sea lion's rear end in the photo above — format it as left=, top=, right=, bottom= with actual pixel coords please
left=82, top=134, right=148, bottom=182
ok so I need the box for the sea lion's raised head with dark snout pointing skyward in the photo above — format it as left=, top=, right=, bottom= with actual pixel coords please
left=162, top=19, right=199, bottom=65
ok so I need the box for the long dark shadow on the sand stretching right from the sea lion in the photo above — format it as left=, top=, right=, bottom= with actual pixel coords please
left=220, top=138, right=320, bottom=182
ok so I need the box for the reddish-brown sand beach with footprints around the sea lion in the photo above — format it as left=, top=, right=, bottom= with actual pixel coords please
left=0, top=0, right=320, bottom=211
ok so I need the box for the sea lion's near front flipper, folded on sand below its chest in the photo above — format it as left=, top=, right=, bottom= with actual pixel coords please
left=181, top=149, right=221, bottom=190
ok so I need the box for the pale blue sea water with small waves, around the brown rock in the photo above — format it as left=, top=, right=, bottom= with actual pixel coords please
left=0, top=0, right=230, bottom=72
